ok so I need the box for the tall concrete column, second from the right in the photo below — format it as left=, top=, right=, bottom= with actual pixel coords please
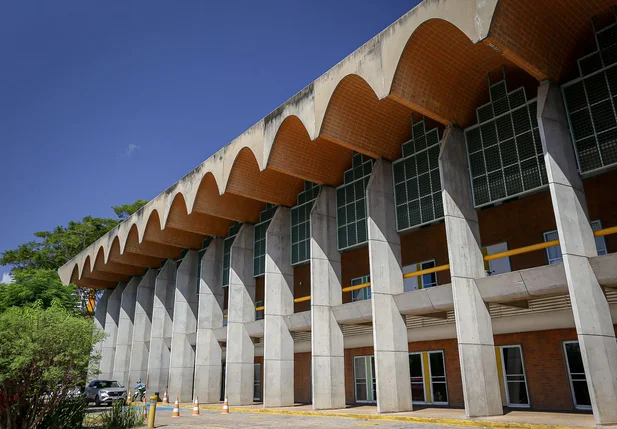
left=439, top=126, right=503, bottom=417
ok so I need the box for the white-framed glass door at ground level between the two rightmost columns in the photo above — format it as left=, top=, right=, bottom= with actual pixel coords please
left=500, top=346, right=529, bottom=408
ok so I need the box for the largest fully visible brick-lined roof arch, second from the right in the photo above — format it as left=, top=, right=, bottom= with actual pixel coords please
left=390, top=19, right=515, bottom=127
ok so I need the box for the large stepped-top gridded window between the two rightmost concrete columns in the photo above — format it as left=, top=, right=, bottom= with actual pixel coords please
left=465, top=80, right=548, bottom=207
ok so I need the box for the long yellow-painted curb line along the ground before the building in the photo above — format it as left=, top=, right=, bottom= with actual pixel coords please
left=168, top=404, right=590, bottom=429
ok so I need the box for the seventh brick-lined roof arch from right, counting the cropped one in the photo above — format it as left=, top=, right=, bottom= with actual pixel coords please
left=165, top=192, right=232, bottom=237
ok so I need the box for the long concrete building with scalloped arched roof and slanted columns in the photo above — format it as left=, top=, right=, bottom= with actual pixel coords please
left=59, top=0, right=617, bottom=424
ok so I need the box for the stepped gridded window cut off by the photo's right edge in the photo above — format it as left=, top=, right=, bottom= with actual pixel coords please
left=562, top=16, right=617, bottom=174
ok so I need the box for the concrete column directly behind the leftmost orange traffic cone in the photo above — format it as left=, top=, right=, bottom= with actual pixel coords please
left=168, top=250, right=199, bottom=402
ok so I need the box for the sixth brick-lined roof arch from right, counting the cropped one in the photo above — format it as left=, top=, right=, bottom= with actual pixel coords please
left=191, top=172, right=264, bottom=223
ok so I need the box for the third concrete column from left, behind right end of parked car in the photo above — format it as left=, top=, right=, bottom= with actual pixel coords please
left=113, top=276, right=141, bottom=391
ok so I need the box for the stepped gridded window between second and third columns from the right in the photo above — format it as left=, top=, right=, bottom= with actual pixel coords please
left=392, top=121, right=443, bottom=231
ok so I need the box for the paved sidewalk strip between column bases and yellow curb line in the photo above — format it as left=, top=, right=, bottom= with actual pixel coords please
left=166, top=403, right=617, bottom=429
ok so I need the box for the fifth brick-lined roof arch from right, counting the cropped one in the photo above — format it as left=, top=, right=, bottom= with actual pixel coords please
left=225, top=148, right=304, bottom=206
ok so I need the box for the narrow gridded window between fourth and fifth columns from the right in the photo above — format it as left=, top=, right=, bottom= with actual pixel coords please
left=291, top=182, right=320, bottom=265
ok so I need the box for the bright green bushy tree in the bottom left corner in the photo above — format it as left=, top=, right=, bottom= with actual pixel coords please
left=0, top=301, right=103, bottom=429
